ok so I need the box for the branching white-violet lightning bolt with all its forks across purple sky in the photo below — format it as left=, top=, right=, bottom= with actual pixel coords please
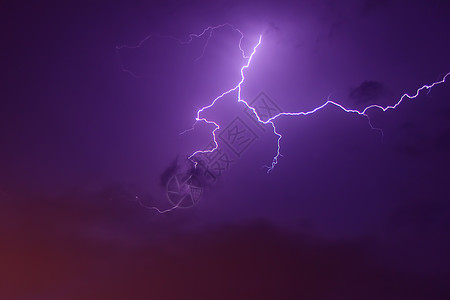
left=116, top=23, right=450, bottom=213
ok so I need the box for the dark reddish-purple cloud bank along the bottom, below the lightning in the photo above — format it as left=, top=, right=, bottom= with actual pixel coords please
left=0, top=193, right=450, bottom=300
